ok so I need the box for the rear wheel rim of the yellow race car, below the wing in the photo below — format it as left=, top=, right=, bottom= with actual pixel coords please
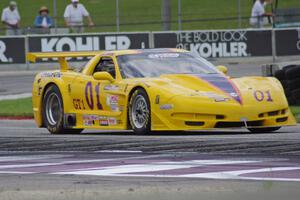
left=46, top=93, right=61, bottom=126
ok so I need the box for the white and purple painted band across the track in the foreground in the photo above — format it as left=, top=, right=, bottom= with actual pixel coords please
left=0, top=154, right=300, bottom=182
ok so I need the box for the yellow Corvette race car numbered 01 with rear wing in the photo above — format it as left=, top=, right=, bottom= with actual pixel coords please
left=27, top=49, right=296, bottom=134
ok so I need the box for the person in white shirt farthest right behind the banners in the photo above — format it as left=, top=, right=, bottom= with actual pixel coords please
left=250, top=0, right=272, bottom=28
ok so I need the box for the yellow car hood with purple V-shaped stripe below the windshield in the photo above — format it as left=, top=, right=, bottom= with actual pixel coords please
left=141, top=74, right=282, bottom=104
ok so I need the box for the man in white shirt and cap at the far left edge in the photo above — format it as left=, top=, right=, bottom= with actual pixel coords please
left=1, top=1, right=21, bottom=35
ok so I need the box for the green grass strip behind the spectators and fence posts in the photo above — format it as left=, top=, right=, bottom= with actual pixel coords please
left=0, top=0, right=300, bottom=32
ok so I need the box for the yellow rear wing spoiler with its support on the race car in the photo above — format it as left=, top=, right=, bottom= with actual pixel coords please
left=27, top=51, right=103, bottom=70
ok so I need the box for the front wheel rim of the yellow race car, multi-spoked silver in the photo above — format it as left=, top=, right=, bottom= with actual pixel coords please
left=131, top=95, right=149, bottom=128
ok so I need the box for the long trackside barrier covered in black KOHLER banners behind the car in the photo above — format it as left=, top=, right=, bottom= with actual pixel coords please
left=0, top=28, right=300, bottom=64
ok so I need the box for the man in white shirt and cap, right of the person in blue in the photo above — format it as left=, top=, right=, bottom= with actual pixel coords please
left=64, top=0, right=94, bottom=33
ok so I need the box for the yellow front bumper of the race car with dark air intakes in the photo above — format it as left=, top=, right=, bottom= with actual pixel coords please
left=152, top=99, right=297, bottom=131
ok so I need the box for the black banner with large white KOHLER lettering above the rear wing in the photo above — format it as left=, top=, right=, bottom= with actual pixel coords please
left=28, top=33, right=149, bottom=60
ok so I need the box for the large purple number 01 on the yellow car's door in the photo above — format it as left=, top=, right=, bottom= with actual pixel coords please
left=85, top=82, right=102, bottom=110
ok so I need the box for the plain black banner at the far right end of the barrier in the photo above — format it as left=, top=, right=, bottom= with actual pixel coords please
left=275, top=29, right=300, bottom=56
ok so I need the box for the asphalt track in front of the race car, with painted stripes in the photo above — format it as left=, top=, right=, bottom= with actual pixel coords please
left=0, top=120, right=300, bottom=200
